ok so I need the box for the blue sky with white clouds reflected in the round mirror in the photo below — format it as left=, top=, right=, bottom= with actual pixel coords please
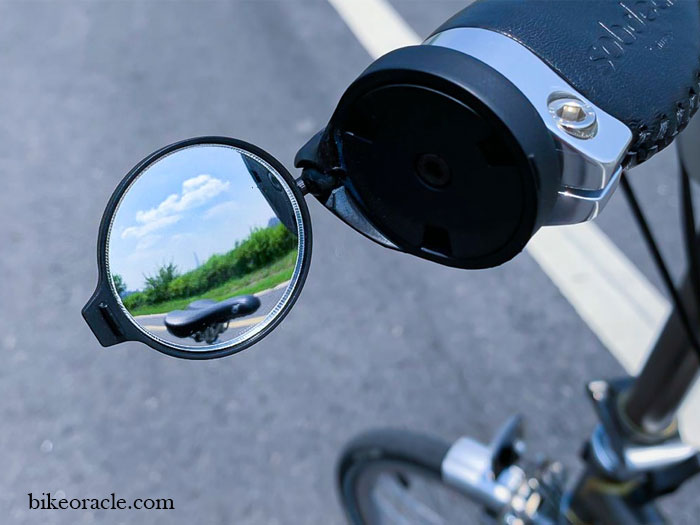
left=109, top=145, right=275, bottom=291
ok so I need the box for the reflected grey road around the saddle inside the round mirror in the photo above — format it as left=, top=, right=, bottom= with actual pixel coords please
left=134, top=287, right=286, bottom=346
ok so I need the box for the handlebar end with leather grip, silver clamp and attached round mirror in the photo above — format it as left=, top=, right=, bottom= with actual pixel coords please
left=83, top=0, right=700, bottom=358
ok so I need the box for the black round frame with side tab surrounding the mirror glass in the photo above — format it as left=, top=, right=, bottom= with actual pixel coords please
left=82, top=136, right=312, bottom=360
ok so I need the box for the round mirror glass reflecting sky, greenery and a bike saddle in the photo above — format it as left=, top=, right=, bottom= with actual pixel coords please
left=107, top=144, right=304, bottom=351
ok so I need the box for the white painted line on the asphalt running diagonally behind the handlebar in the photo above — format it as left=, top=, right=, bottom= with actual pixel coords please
left=328, top=0, right=700, bottom=446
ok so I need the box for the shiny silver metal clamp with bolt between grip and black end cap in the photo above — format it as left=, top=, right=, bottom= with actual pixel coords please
left=425, top=27, right=632, bottom=225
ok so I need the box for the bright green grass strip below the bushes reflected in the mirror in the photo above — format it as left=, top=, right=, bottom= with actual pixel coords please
left=129, top=250, right=297, bottom=316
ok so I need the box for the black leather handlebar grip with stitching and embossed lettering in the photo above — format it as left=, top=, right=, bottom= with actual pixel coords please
left=436, top=0, right=700, bottom=166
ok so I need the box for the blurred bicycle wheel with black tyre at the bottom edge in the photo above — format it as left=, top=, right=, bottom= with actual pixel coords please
left=337, top=430, right=484, bottom=525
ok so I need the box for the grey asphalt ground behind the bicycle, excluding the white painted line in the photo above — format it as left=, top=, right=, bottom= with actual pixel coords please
left=0, top=0, right=700, bottom=525
